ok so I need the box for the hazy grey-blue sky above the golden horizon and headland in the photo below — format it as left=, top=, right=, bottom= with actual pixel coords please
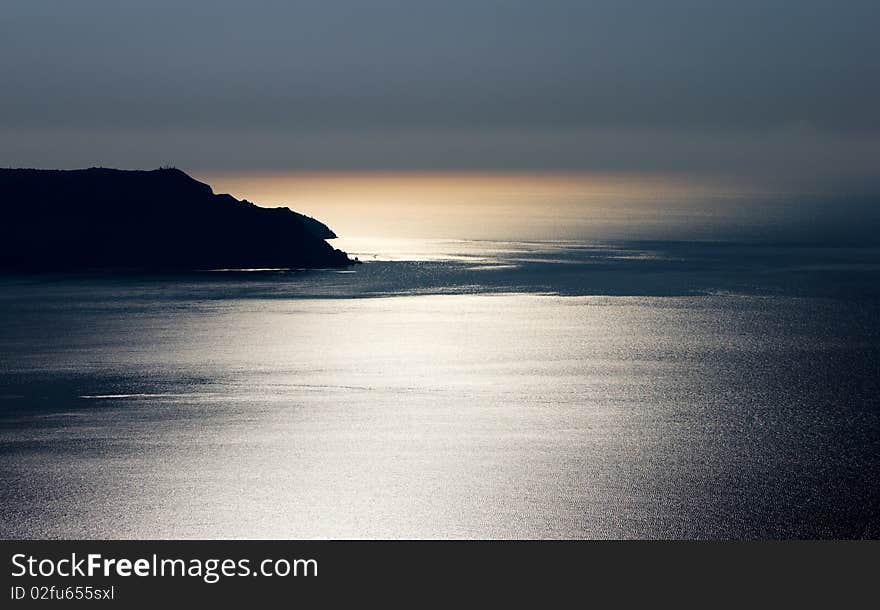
left=0, top=0, right=880, bottom=181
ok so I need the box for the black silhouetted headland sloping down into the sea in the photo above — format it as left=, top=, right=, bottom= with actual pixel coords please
left=0, top=168, right=355, bottom=271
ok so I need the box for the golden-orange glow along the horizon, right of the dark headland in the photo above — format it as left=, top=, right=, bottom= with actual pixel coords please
left=195, top=172, right=768, bottom=240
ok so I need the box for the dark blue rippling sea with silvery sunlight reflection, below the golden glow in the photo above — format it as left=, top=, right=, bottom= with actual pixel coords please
left=0, top=242, right=880, bottom=538
